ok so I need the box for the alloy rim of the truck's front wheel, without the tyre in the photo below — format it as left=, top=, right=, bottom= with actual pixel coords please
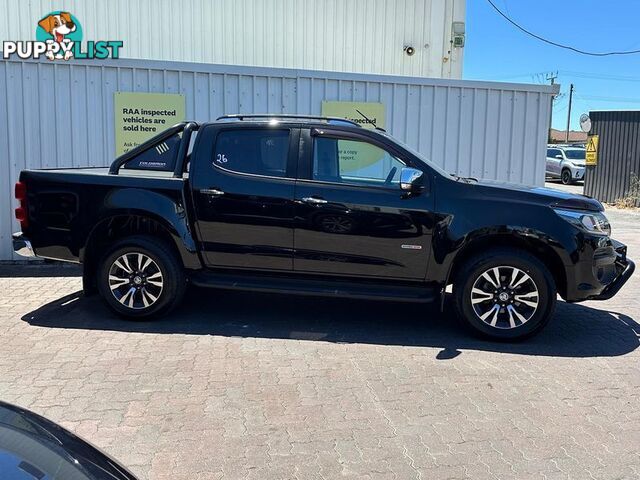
left=471, top=266, right=540, bottom=329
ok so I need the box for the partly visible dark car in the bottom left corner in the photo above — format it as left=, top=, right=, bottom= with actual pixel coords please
left=0, top=401, right=136, bottom=480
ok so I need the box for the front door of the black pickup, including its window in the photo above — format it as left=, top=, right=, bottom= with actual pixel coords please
left=294, top=129, right=433, bottom=280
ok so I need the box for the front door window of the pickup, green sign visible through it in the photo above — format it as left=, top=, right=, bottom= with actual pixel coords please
left=313, top=137, right=405, bottom=186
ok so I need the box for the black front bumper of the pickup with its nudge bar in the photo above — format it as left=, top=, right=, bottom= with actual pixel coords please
left=565, top=239, right=636, bottom=302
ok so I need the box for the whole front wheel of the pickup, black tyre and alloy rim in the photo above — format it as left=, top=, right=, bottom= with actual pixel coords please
left=453, top=248, right=557, bottom=341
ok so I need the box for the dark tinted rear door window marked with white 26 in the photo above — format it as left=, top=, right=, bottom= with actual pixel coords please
left=213, top=128, right=289, bottom=177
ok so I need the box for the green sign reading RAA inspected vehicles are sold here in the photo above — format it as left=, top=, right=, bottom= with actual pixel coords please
left=113, top=92, right=185, bottom=156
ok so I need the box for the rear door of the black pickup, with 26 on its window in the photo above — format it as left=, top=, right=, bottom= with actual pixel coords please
left=191, top=124, right=299, bottom=270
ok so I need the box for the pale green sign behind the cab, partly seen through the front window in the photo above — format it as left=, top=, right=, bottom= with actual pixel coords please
left=322, top=102, right=384, bottom=175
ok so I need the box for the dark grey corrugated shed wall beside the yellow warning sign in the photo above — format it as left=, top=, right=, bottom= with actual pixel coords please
left=584, top=111, right=640, bottom=202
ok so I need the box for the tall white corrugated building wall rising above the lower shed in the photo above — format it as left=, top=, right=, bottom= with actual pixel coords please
left=0, top=0, right=465, bottom=78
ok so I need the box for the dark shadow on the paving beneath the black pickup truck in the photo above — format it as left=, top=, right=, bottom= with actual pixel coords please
left=22, top=288, right=640, bottom=360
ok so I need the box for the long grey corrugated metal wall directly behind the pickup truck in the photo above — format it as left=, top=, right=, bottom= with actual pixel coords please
left=0, top=59, right=554, bottom=260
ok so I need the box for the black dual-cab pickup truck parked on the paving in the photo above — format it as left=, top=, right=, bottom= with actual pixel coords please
left=13, top=115, right=634, bottom=340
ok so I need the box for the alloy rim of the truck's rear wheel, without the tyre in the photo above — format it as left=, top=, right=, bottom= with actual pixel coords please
left=109, top=252, right=164, bottom=310
